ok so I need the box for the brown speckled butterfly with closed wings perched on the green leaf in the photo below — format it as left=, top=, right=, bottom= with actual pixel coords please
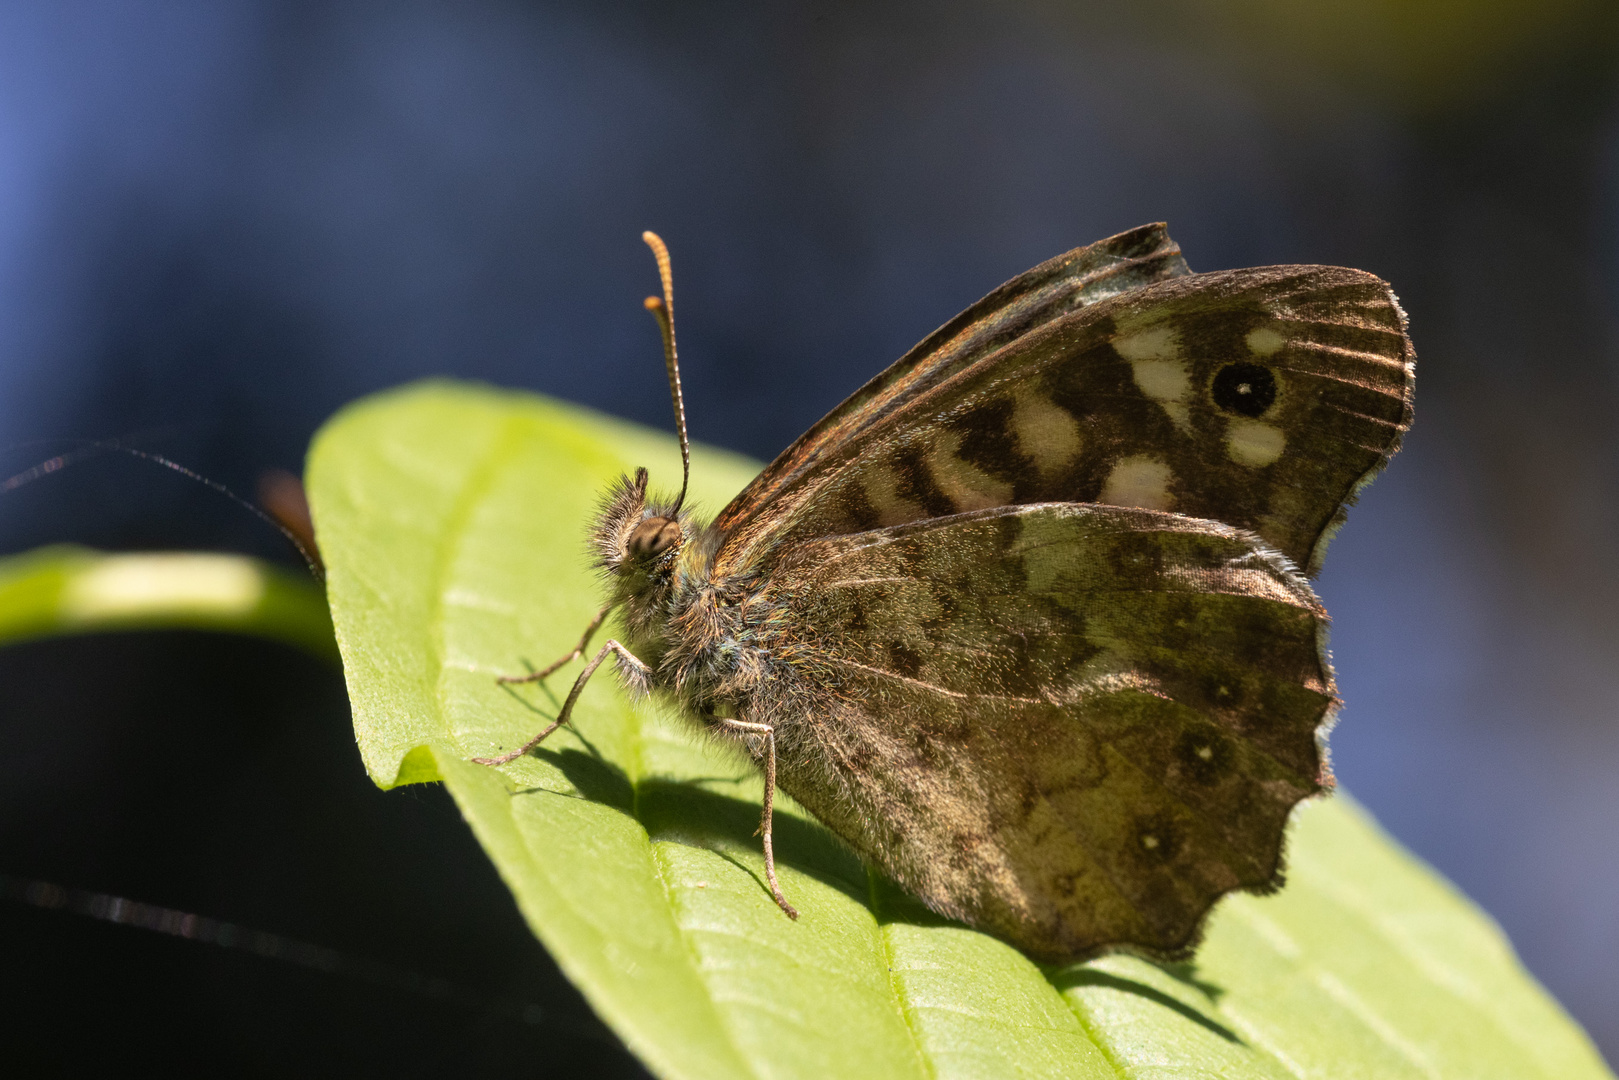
left=479, top=223, right=1415, bottom=962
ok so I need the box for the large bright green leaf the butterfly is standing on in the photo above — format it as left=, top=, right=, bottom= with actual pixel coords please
left=309, top=375, right=1609, bottom=1080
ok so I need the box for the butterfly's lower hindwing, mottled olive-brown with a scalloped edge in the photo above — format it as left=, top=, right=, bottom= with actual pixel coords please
left=753, top=505, right=1334, bottom=960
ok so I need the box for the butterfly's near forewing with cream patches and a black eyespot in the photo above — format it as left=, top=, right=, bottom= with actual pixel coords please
left=716, top=266, right=1413, bottom=573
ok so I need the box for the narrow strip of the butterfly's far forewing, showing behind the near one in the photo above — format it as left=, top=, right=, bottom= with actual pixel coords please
left=714, top=222, right=1192, bottom=544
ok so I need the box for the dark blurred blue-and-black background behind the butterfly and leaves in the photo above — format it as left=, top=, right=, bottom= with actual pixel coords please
left=0, top=0, right=1619, bottom=1075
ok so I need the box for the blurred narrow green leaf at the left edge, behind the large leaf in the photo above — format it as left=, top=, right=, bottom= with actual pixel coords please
left=0, top=544, right=337, bottom=661
